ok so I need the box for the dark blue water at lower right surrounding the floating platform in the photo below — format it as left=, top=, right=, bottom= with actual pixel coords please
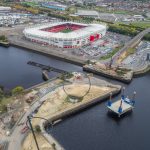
left=50, top=74, right=150, bottom=150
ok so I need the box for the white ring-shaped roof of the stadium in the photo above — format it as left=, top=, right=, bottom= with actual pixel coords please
left=23, top=22, right=106, bottom=39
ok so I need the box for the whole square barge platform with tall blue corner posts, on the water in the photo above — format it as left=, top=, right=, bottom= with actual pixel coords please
left=107, top=89, right=136, bottom=117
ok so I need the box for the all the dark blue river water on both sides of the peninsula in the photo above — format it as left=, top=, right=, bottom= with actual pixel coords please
left=0, top=47, right=150, bottom=150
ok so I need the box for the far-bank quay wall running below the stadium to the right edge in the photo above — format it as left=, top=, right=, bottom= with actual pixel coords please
left=10, top=40, right=150, bottom=83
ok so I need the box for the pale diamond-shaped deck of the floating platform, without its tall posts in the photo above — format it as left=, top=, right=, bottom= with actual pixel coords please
left=107, top=100, right=134, bottom=117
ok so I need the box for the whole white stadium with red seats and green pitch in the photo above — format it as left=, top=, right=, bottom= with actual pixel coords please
left=23, top=22, right=106, bottom=48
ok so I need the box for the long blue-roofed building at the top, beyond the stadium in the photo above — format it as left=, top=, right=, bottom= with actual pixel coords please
left=41, top=2, right=67, bottom=11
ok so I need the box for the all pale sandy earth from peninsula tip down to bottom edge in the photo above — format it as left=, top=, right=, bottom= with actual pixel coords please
left=22, top=80, right=117, bottom=150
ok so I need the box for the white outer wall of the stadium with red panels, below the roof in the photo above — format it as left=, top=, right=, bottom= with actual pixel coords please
left=23, top=21, right=106, bottom=48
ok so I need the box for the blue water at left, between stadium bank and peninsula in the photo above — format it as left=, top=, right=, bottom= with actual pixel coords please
left=0, top=47, right=82, bottom=89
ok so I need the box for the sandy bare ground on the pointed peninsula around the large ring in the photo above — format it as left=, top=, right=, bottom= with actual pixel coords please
left=32, top=84, right=113, bottom=126
